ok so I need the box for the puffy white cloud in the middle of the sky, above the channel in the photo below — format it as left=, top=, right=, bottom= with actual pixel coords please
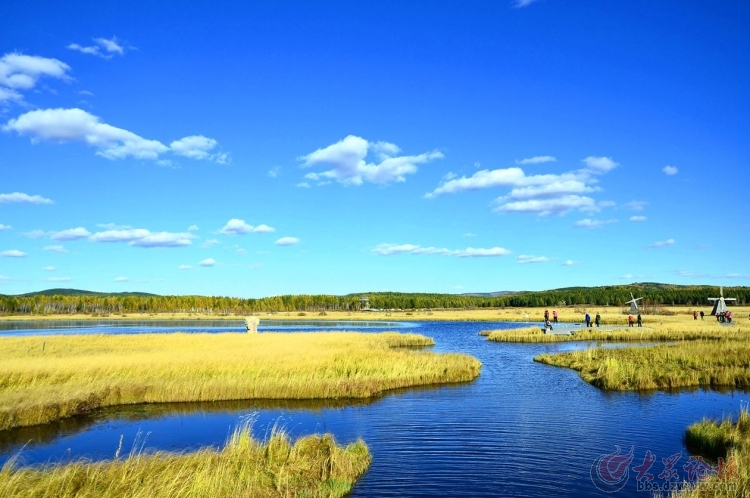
left=299, top=135, right=443, bottom=185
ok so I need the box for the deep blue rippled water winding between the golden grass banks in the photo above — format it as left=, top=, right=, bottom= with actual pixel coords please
left=0, top=322, right=749, bottom=497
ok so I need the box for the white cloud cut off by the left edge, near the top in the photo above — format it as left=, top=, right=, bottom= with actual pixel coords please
left=0, top=53, right=70, bottom=104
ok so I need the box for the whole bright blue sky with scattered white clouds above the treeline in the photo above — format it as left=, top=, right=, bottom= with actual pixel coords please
left=0, top=0, right=750, bottom=297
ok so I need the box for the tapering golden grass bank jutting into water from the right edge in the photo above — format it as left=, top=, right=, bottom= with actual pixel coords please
left=534, top=331, right=750, bottom=391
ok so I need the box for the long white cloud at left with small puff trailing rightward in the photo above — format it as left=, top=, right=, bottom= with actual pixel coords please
left=3, top=108, right=229, bottom=163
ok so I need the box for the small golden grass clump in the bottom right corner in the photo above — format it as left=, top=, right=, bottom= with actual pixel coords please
left=671, top=408, right=750, bottom=498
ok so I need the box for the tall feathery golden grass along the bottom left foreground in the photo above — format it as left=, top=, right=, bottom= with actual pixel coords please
left=0, top=427, right=371, bottom=498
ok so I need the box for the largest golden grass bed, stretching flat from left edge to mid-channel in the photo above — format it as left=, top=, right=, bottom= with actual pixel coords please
left=0, top=332, right=481, bottom=430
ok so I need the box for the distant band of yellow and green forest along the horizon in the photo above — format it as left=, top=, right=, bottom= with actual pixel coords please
left=0, top=283, right=750, bottom=315
